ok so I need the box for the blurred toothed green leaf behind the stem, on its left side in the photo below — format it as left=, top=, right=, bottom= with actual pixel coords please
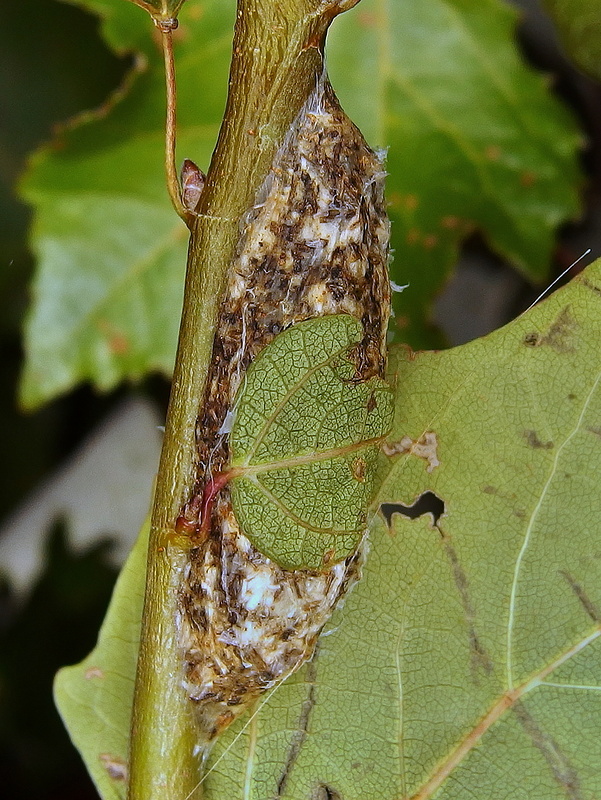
left=21, top=0, right=234, bottom=407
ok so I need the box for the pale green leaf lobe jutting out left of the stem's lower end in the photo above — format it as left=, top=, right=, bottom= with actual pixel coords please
left=54, top=521, right=150, bottom=800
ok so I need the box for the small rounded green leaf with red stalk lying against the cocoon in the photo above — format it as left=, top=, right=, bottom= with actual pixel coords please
left=230, top=315, right=393, bottom=569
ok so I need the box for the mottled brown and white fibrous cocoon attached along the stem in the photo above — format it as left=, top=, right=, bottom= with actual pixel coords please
left=178, top=76, right=390, bottom=743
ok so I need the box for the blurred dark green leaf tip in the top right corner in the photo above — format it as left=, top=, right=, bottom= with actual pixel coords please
left=544, top=0, right=601, bottom=80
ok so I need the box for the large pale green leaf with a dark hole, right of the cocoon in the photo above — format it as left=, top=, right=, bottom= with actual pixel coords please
left=57, top=262, right=601, bottom=800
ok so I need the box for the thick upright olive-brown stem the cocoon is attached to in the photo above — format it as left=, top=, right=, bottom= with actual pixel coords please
left=128, top=0, right=358, bottom=800
